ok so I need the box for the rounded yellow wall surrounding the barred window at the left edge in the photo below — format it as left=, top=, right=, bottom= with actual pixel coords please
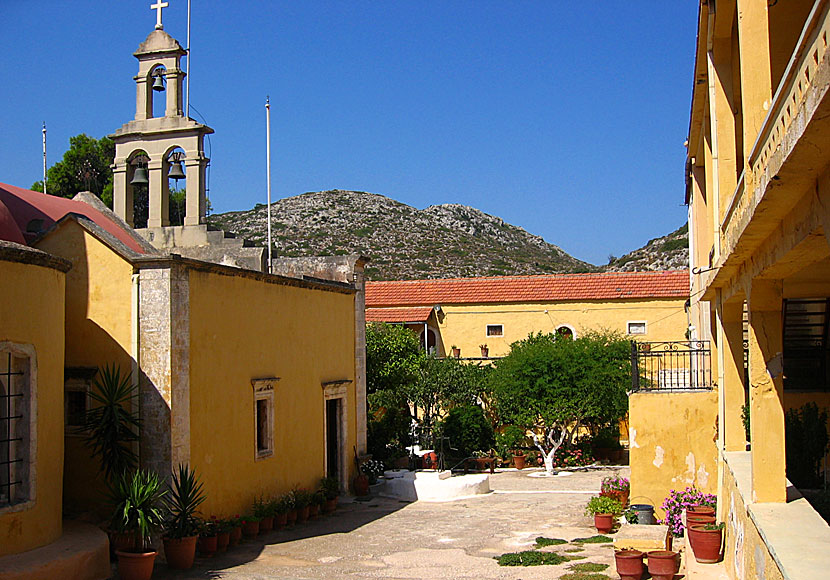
left=0, top=260, right=65, bottom=556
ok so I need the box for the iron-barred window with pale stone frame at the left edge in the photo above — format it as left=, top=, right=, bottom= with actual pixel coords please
left=0, top=343, right=35, bottom=508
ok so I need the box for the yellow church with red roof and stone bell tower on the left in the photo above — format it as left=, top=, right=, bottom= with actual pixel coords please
left=0, top=14, right=366, bottom=579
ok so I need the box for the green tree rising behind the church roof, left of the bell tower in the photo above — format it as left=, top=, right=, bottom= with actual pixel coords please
left=32, top=133, right=115, bottom=207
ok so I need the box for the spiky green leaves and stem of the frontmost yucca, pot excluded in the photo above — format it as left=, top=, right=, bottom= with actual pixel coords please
left=110, top=469, right=167, bottom=552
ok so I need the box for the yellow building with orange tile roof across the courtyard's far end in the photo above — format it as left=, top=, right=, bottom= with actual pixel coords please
left=366, top=271, right=689, bottom=359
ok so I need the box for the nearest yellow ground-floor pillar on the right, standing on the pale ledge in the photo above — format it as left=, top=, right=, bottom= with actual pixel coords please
left=747, top=279, right=787, bottom=502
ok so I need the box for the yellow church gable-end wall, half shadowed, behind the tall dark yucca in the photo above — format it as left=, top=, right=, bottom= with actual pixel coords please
left=38, top=221, right=133, bottom=510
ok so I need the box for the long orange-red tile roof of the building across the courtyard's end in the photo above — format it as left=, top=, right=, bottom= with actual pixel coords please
left=366, top=270, right=689, bottom=308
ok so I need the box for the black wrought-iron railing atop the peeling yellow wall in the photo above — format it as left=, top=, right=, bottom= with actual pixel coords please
left=631, top=340, right=712, bottom=391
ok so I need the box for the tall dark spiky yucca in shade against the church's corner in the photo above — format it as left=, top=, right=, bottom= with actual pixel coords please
left=84, top=365, right=141, bottom=482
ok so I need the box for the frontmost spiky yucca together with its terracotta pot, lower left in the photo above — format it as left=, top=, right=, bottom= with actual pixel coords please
left=110, top=470, right=167, bottom=580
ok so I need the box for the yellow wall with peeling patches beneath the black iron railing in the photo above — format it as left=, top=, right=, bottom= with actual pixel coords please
left=628, top=391, right=718, bottom=518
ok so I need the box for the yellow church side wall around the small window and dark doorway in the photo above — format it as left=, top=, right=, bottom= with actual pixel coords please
left=189, top=271, right=356, bottom=515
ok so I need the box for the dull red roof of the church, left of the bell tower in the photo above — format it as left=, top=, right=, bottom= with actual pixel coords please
left=0, top=183, right=146, bottom=254
